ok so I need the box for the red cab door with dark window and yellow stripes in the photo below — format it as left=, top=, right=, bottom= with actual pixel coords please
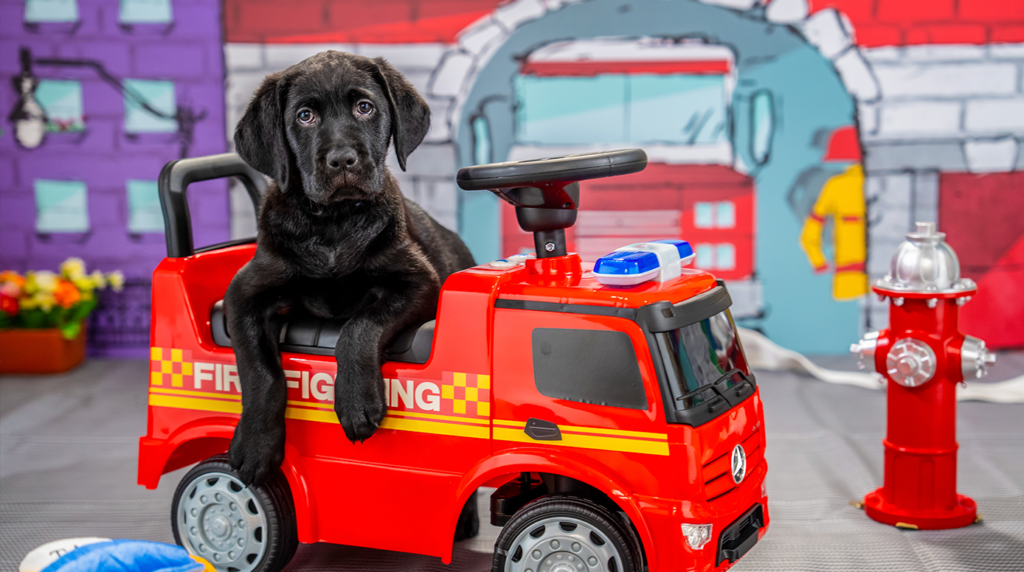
left=493, top=300, right=669, bottom=492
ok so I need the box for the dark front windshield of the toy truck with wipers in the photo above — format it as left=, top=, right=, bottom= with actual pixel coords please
left=662, top=310, right=751, bottom=409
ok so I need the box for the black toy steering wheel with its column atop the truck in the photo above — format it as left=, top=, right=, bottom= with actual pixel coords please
left=456, top=149, right=647, bottom=258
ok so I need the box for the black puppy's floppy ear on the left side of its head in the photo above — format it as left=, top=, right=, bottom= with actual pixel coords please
left=234, top=72, right=292, bottom=189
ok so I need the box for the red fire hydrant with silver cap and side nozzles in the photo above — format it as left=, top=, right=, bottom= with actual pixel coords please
left=850, top=222, right=995, bottom=529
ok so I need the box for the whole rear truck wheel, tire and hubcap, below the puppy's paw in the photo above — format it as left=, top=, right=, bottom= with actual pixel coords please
left=171, top=455, right=299, bottom=572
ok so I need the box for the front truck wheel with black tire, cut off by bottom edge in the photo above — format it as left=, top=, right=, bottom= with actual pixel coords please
left=492, top=496, right=642, bottom=572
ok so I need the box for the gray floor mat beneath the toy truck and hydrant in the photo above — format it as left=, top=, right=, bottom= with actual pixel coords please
left=0, top=354, right=1024, bottom=572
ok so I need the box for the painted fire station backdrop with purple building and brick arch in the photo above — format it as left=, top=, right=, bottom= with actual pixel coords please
left=0, top=0, right=1024, bottom=353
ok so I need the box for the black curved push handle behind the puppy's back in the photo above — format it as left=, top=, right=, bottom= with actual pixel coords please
left=158, top=152, right=266, bottom=258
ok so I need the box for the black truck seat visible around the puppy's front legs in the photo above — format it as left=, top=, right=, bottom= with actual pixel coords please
left=210, top=300, right=434, bottom=363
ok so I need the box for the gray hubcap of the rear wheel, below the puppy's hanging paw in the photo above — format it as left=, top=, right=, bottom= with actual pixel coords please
left=176, top=473, right=268, bottom=572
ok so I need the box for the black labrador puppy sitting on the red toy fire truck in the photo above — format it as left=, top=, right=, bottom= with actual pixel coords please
left=224, top=51, right=473, bottom=484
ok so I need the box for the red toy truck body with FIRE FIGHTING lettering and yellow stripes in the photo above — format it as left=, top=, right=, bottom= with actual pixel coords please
left=138, top=244, right=768, bottom=572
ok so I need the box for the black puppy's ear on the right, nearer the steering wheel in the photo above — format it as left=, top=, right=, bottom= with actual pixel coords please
left=374, top=57, right=430, bottom=171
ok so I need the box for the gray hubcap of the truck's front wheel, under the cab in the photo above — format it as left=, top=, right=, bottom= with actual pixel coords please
left=505, top=517, right=623, bottom=572
